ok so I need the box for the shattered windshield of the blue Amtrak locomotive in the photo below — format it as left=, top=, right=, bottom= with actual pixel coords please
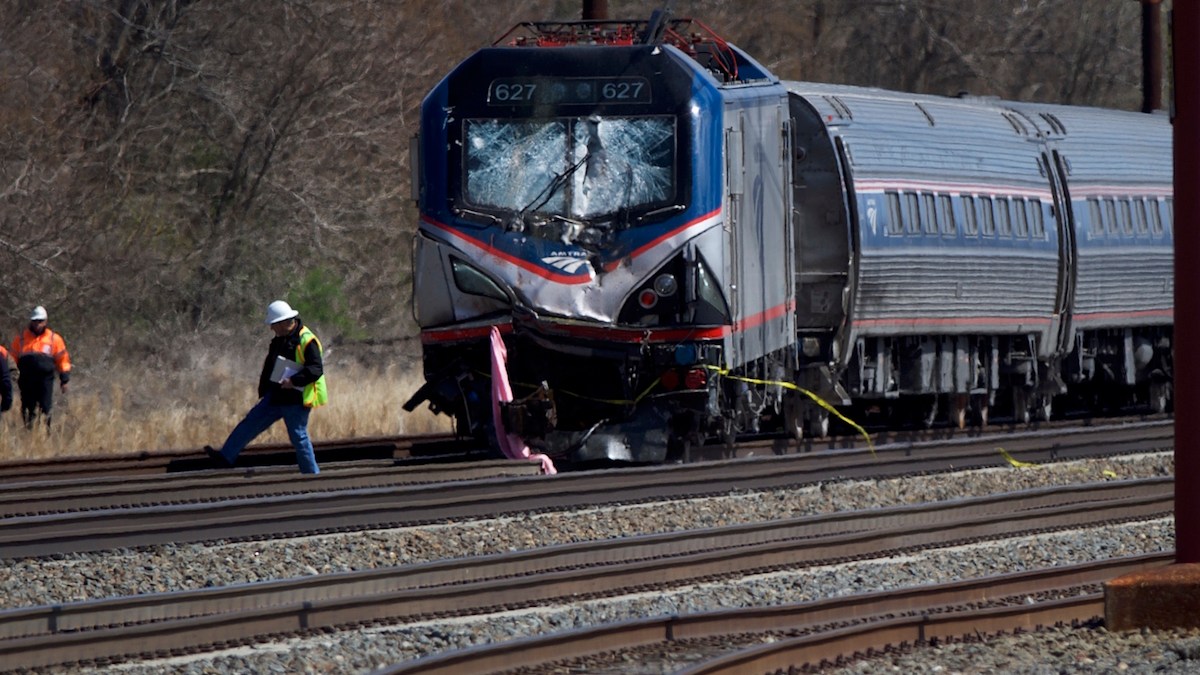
left=464, top=115, right=676, bottom=219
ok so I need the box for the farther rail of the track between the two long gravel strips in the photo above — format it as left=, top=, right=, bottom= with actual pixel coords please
left=0, top=479, right=1171, bottom=638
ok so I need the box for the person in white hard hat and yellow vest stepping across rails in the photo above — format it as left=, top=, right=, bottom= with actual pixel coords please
left=204, top=300, right=329, bottom=473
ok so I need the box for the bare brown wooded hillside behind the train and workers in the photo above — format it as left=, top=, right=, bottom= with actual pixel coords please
left=0, top=0, right=1171, bottom=455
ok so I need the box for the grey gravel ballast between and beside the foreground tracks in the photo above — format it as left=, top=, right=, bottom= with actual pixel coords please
left=0, top=453, right=1180, bottom=673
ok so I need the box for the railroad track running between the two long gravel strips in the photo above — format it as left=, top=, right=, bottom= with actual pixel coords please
left=0, top=478, right=1174, bottom=673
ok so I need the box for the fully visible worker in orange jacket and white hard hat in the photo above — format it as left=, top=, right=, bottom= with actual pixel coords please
left=11, top=305, right=71, bottom=429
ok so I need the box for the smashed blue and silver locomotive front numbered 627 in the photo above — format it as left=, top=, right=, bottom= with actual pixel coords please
left=406, top=15, right=784, bottom=462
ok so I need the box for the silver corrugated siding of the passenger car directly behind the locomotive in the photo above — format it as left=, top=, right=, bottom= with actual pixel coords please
left=782, top=86, right=1058, bottom=340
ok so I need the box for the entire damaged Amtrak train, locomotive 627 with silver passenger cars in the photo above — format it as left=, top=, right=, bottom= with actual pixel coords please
left=404, top=12, right=1174, bottom=462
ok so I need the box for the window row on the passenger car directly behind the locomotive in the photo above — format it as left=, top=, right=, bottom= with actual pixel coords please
left=884, top=192, right=1046, bottom=239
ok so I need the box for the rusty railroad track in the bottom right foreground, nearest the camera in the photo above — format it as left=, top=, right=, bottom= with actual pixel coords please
left=384, top=554, right=1174, bottom=675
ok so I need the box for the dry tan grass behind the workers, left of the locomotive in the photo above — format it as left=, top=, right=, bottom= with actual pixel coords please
left=0, top=343, right=452, bottom=461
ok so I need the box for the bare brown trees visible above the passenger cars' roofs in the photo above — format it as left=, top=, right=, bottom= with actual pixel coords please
left=610, top=0, right=1152, bottom=109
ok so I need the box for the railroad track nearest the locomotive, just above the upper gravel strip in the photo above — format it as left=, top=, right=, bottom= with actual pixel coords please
left=0, top=422, right=1174, bottom=560
